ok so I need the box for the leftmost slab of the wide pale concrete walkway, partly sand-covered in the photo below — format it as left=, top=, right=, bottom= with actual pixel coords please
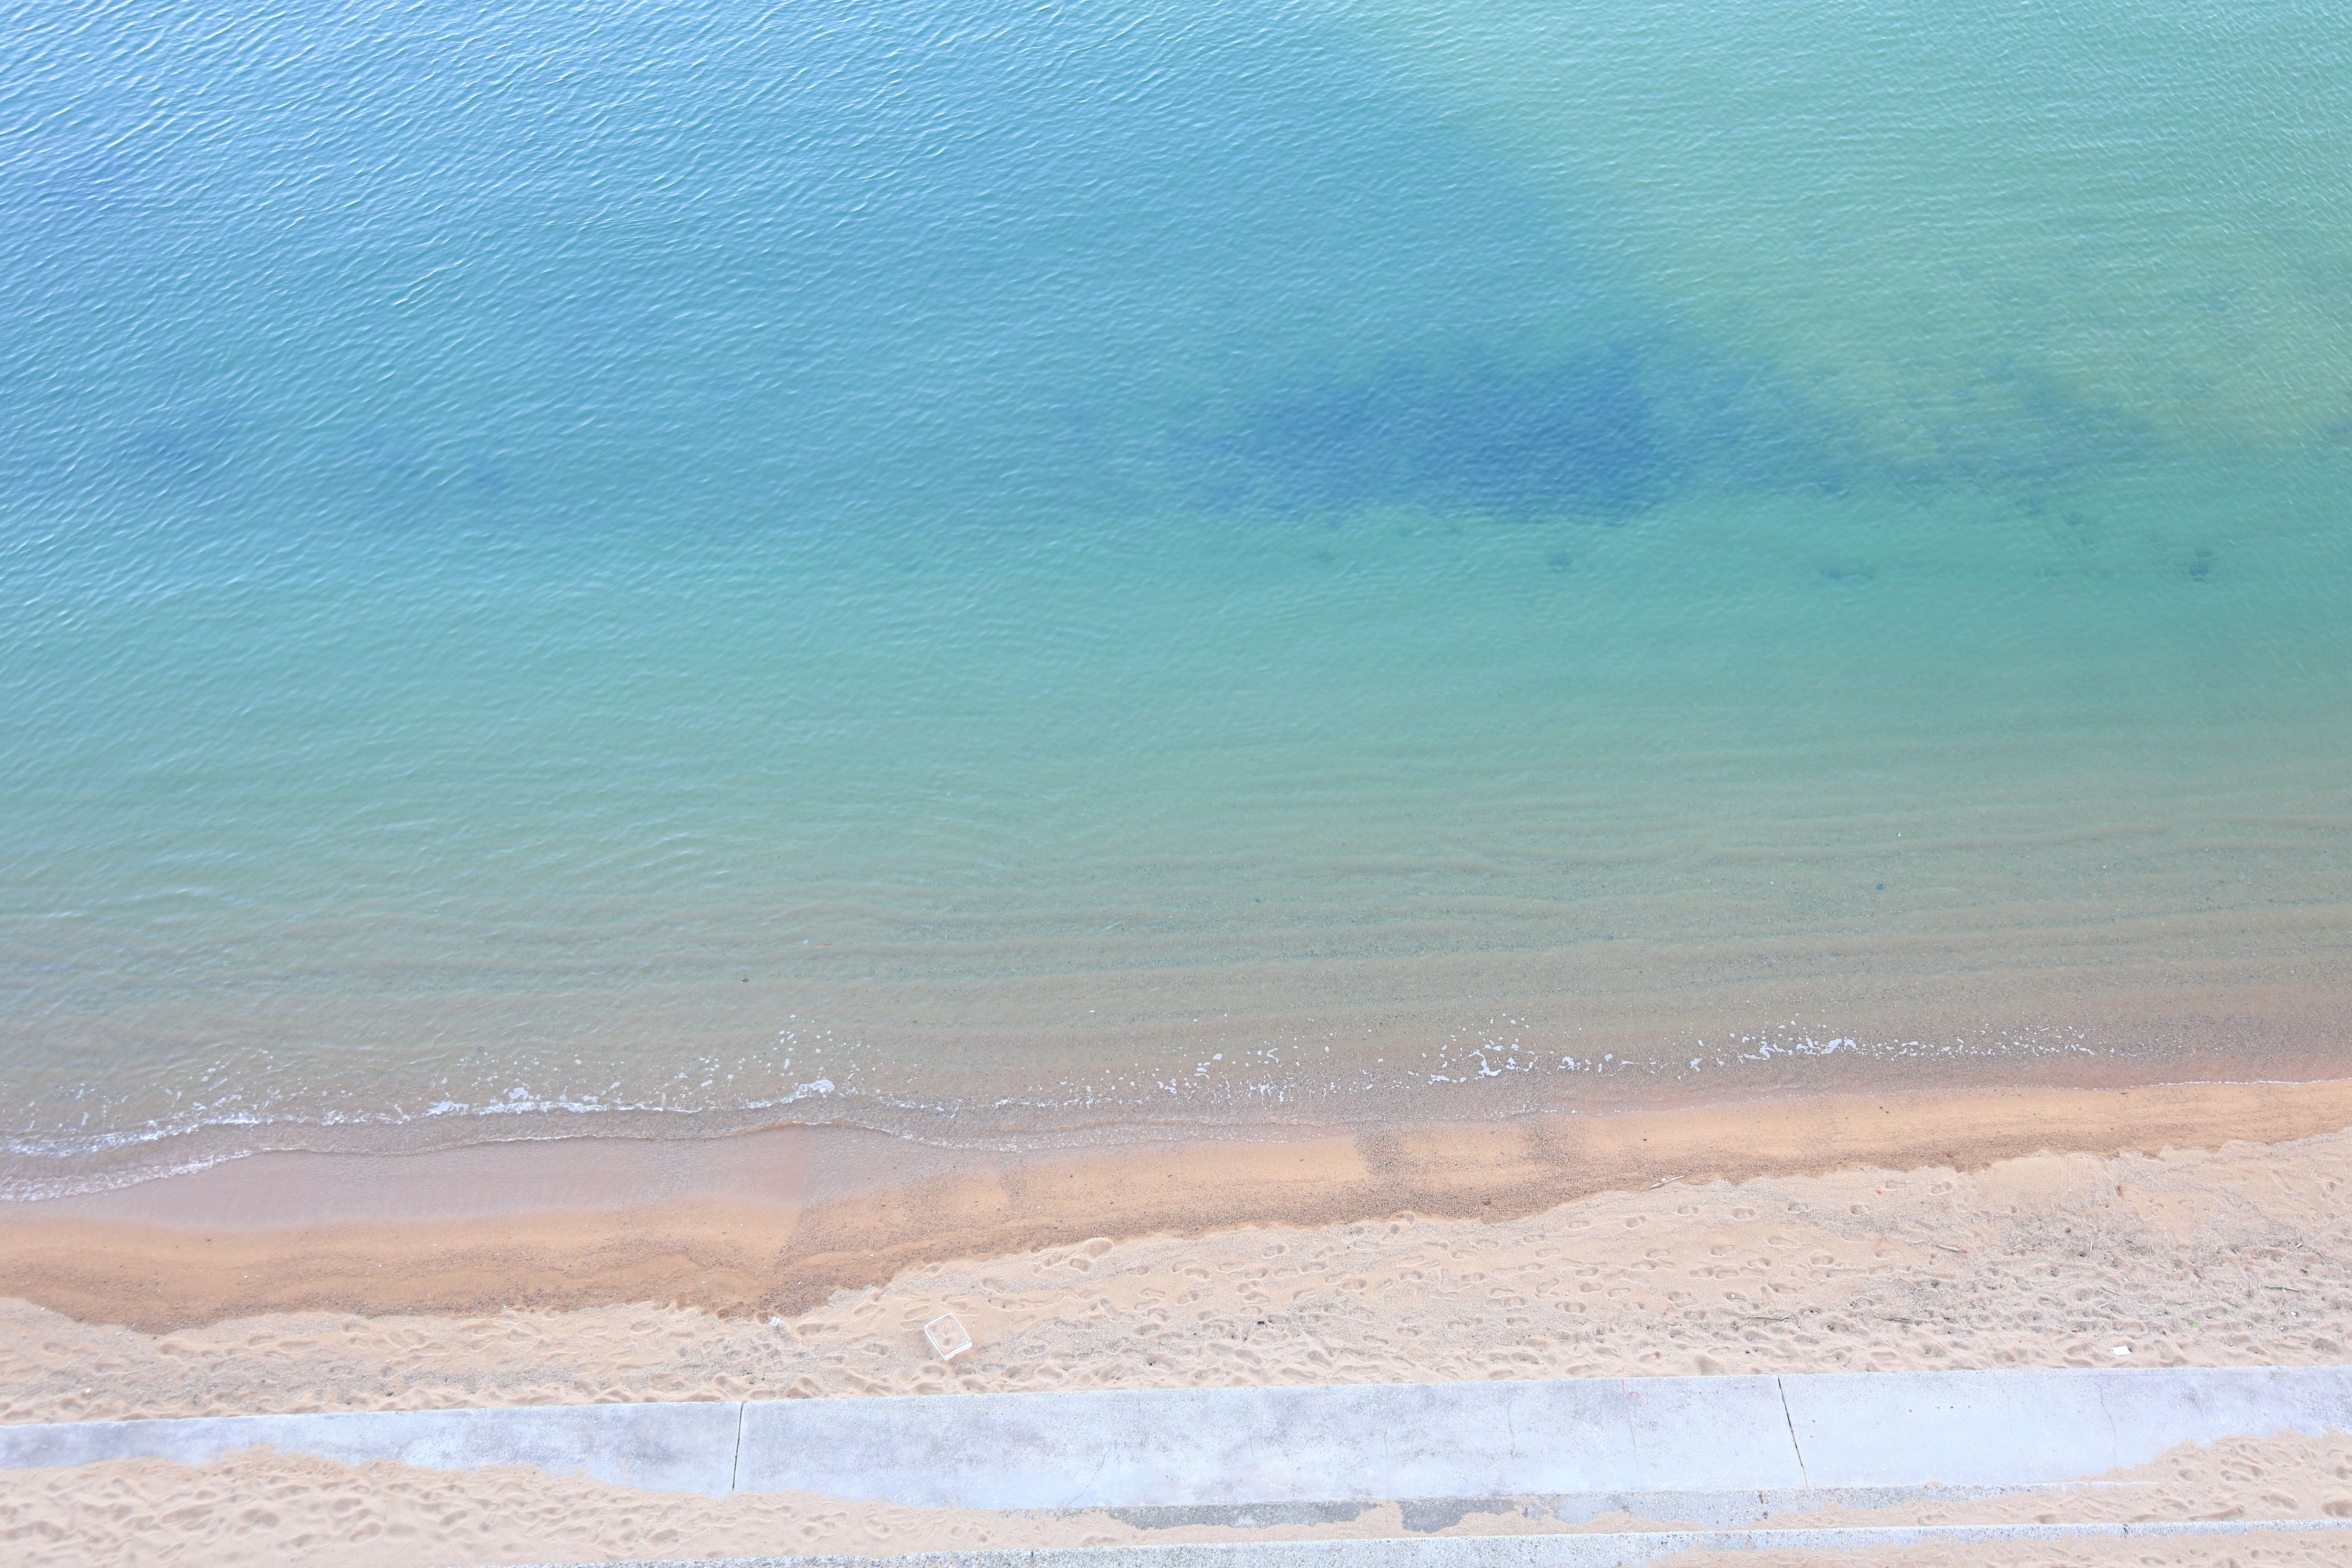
left=0, top=1401, right=743, bottom=1498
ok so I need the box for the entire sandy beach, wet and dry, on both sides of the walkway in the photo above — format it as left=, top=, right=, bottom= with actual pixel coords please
left=0, top=1084, right=2352, bottom=1563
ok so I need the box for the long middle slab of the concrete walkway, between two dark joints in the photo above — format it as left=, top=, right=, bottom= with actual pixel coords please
left=736, top=1377, right=1804, bottom=1509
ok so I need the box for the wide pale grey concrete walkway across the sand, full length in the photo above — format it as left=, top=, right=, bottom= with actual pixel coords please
left=0, top=1368, right=2352, bottom=1523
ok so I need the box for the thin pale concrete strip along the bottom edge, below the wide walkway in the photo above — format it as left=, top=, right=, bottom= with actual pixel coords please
left=532, top=1519, right=2352, bottom=1568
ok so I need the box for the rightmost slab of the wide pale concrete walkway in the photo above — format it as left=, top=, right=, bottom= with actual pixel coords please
left=1781, top=1366, right=2352, bottom=1486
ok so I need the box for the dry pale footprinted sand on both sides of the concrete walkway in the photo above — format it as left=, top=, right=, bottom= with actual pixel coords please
left=0, top=1100, right=2352, bottom=1568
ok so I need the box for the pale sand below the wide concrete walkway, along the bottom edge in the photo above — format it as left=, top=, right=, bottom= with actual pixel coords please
left=14, top=1434, right=2352, bottom=1568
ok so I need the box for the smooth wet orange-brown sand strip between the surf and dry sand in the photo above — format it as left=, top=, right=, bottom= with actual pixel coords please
left=0, top=1079, right=2352, bottom=1333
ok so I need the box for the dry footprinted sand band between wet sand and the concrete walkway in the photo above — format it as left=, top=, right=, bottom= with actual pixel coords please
left=0, top=1133, right=2352, bottom=1422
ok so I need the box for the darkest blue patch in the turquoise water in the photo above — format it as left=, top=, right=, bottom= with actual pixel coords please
left=1195, top=343, right=1667, bottom=520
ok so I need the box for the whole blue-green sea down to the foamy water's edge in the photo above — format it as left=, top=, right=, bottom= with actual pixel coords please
left=0, top=0, right=2352, bottom=1194
